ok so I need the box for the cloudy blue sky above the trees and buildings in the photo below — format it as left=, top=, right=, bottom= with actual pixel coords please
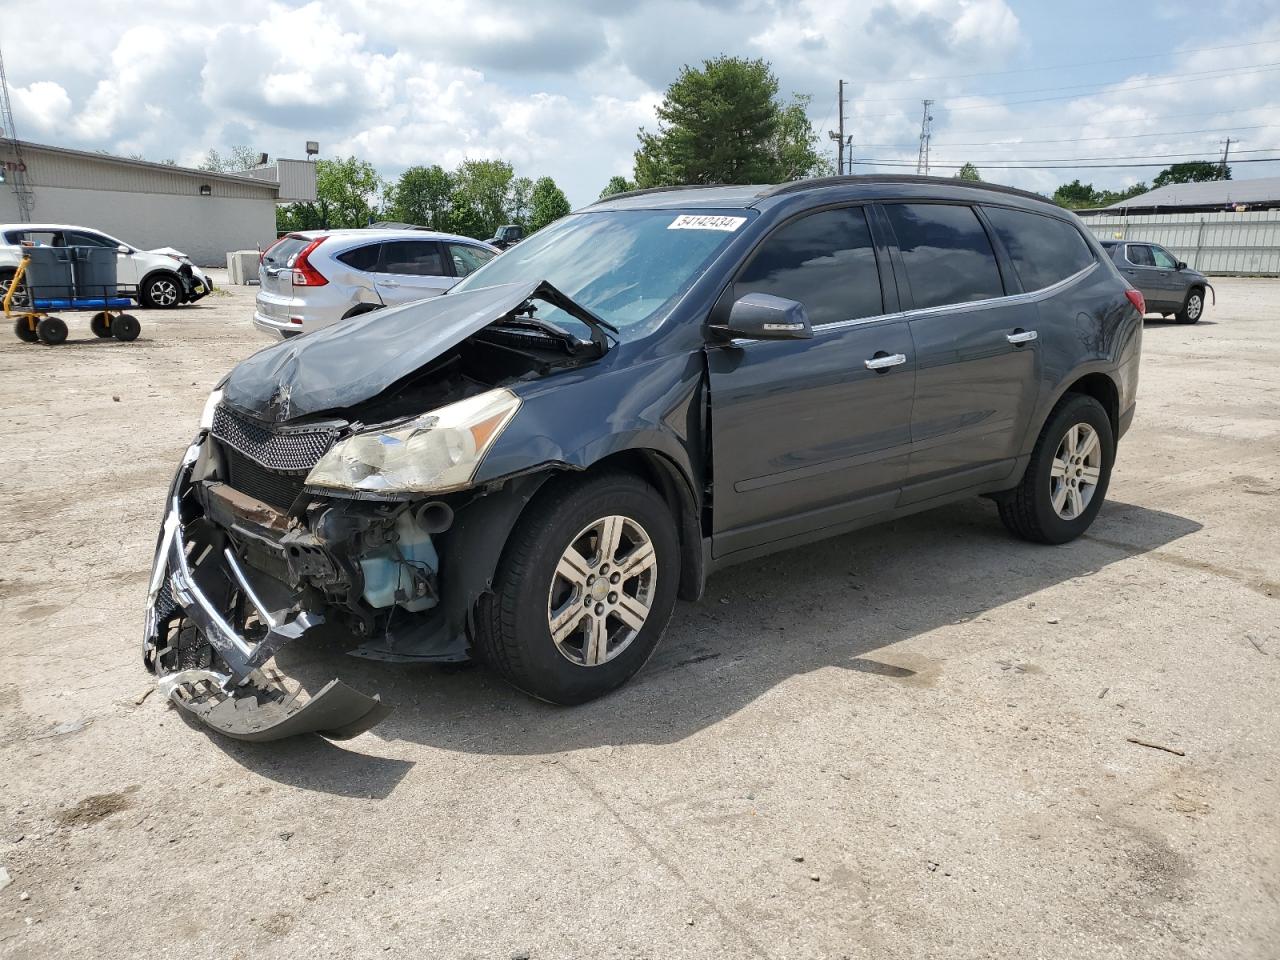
left=0, top=0, right=1280, bottom=206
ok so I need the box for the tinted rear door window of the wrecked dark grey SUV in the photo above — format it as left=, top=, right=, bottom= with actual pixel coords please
left=884, top=204, right=1005, bottom=308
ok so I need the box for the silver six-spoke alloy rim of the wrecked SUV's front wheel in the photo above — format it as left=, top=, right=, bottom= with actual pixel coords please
left=547, top=515, right=658, bottom=667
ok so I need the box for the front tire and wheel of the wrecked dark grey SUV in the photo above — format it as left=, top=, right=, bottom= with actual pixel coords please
left=475, top=472, right=680, bottom=705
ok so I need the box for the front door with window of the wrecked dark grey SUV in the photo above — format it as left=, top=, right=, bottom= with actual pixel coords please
left=707, top=206, right=915, bottom=557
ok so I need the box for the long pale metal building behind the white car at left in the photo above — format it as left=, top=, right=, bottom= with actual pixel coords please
left=0, top=138, right=316, bottom=266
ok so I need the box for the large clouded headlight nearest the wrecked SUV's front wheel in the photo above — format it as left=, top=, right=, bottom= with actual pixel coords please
left=307, top=389, right=520, bottom=493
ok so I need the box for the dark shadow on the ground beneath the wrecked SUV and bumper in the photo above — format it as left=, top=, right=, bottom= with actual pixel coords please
left=210, top=500, right=1201, bottom=796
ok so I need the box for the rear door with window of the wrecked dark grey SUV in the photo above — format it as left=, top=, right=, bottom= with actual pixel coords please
left=882, top=202, right=1039, bottom=503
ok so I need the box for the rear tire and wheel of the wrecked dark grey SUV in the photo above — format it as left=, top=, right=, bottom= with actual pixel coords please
left=998, top=393, right=1116, bottom=544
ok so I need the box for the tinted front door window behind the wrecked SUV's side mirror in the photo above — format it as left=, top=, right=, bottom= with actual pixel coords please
left=733, top=207, right=884, bottom=325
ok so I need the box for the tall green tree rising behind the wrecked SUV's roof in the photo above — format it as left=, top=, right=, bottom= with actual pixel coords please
left=635, top=56, right=823, bottom=187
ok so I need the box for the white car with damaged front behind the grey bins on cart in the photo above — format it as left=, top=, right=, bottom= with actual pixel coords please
left=0, top=223, right=214, bottom=310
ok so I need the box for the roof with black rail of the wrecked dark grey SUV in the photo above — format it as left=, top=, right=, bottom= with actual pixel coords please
left=589, top=179, right=1052, bottom=210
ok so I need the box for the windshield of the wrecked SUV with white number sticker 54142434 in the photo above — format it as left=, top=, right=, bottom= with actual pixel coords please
left=453, top=210, right=753, bottom=335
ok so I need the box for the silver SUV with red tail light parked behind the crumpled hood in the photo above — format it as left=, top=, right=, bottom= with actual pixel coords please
left=253, top=228, right=498, bottom=337
